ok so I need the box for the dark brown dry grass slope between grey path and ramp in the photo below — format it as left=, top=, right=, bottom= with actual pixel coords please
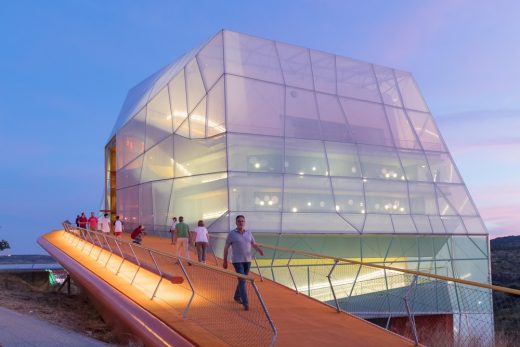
left=0, top=273, right=118, bottom=347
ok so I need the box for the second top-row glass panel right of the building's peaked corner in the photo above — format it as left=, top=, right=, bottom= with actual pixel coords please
left=276, top=42, right=314, bottom=90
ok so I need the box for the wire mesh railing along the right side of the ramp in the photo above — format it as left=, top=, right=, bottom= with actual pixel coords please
left=211, top=235, right=520, bottom=346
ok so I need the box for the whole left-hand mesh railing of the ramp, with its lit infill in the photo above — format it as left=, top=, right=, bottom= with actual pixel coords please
left=63, top=224, right=277, bottom=346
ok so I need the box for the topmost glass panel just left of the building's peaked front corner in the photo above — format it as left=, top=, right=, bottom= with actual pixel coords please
left=197, top=32, right=224, bottom=89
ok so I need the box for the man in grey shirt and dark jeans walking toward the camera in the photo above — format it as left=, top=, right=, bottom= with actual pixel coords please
left=223, top=215, right=264, bottom=311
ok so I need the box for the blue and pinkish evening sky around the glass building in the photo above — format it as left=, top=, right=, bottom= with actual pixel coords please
left=0, top=0, right=520, bottom=254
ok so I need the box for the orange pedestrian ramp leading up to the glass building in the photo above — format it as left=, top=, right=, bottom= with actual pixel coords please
left=38, top=225, right=414, bottom=346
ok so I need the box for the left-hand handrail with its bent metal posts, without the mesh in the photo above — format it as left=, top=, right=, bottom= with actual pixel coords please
left=63, top=223, right=278, bottom=346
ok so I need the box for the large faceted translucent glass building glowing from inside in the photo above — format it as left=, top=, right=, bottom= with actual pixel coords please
left=105, top=30, right=490, bottom=340
